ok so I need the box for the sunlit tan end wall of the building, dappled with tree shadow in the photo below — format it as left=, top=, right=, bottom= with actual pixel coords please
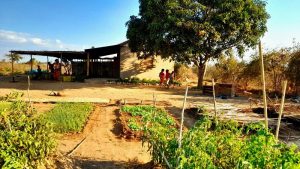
left=120, top=44, right=174, bottom=80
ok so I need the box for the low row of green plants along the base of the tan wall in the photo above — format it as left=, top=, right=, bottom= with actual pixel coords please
left=107, top=77, right=181, bottom=86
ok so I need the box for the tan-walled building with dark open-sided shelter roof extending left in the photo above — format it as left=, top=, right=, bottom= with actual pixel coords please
left=11, top=41, right=174, bottom=79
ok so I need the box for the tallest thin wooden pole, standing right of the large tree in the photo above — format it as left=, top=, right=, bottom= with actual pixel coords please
left=258, top=41, right=269, bottom=131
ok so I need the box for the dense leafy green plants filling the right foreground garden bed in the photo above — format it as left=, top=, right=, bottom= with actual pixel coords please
left=123, top=106, right=300, bottom=168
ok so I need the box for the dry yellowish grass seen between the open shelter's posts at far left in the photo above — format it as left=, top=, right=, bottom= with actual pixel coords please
left=0, top=62, right=47, bottom=75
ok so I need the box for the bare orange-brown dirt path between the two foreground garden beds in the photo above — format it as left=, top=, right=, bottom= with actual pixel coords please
left=58, top=106, right=150, bottom=169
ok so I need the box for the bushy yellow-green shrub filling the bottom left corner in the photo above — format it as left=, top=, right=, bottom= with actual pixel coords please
left=0, top=94, right=55, bottom=169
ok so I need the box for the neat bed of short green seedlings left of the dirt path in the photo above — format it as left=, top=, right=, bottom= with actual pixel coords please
left=42, top=103, right=93, bottom=133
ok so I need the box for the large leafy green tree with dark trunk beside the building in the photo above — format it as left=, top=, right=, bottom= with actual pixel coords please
left=127, top=0, right=269, bottom=87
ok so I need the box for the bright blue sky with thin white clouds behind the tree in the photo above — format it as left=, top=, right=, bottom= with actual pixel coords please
left=0, top=0, right=300, bottom=62
